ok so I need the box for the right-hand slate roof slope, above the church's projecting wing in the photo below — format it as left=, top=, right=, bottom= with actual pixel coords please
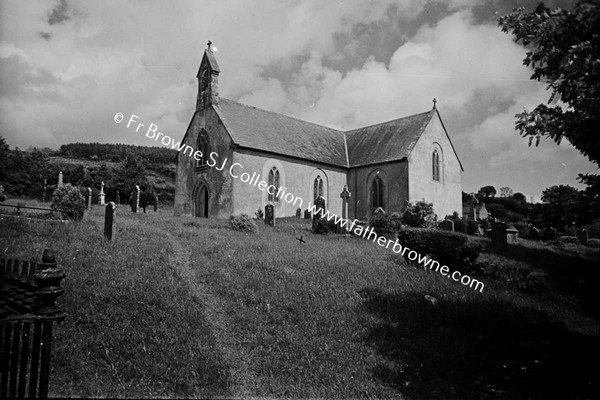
left=346, top=110, right=434, bottom=167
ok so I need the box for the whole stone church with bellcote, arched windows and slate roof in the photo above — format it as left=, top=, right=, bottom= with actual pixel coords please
left=175, top=42, right=463, bottom=220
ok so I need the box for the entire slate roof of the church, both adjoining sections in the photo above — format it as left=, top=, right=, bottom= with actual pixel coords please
left=214, top=97, right=435, bottom=167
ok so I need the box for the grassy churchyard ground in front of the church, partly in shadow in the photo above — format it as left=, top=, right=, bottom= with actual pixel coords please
left=0, top=202, right=598, bottom=399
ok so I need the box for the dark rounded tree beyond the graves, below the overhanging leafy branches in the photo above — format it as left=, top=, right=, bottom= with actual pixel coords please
left=542, top=185, right=581, bottom=227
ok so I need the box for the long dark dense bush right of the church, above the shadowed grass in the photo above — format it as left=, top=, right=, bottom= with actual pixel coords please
left=398, top=228, right=482, bottom=270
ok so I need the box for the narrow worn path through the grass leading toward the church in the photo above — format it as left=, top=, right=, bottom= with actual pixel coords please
left=157, top=228, right=256, bottom=397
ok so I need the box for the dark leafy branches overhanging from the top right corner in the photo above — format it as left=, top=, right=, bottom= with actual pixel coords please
left=498, top=0, right=600, bottom=164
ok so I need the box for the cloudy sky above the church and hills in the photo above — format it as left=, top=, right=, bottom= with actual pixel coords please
left=0, top=0, right=597, bottom=199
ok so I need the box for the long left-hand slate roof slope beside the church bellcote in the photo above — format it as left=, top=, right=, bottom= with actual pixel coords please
left=214, top=97, right=348, bottom=167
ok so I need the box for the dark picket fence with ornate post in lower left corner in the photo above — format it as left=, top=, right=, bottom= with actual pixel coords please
left=0, top=250, right=65, bottom=398
